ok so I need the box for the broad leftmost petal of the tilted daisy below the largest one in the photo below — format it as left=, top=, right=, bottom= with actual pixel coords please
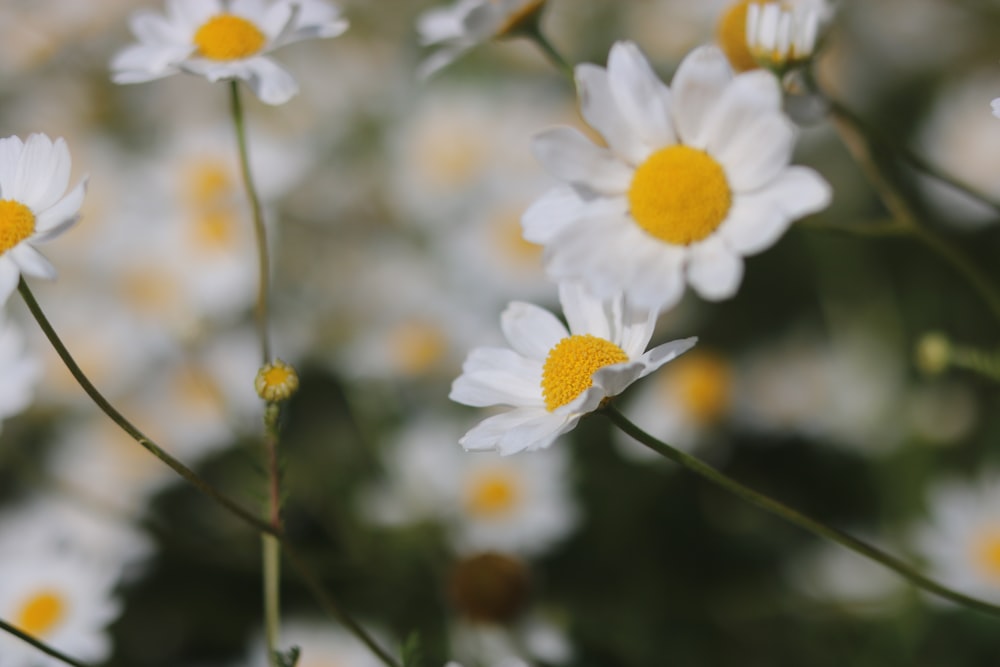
left=448, top=348, right=545, bottom=408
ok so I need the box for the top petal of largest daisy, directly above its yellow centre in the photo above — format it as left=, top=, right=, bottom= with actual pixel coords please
left=671, top=46, right=733, bottom=144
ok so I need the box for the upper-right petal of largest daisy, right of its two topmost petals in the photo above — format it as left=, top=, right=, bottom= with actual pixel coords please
left=693, top=70, right=781, bottom=155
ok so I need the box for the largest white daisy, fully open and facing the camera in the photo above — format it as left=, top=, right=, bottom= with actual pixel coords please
left=522, top=42, right=831, bottom=308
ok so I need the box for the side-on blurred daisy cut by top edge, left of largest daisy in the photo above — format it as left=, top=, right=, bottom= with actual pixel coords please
left=417, top=0, right=545, bottom=76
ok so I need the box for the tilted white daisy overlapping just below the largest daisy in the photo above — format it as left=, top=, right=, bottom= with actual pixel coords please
left=450, top=283, right=697, bottom=455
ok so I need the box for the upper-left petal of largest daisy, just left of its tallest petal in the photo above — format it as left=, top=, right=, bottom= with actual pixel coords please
left=576, top=63, right=650, bottom=165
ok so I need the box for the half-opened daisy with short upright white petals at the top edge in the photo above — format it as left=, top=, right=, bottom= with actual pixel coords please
left=746, top=2, right=820, bottom=73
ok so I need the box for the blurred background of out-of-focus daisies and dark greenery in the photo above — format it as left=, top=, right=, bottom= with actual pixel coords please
left=0, top=0, right=1000, bottom=667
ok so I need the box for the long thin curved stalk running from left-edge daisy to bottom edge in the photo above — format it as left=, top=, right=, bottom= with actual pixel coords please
left=14, top=278, right=399, bottom=667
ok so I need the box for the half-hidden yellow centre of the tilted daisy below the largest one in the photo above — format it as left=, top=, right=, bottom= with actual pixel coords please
left=542, top=334, right=628, bottom=412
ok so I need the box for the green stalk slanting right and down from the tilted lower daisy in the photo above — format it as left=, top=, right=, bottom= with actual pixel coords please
left=601, top=404, right=1000, bottom=616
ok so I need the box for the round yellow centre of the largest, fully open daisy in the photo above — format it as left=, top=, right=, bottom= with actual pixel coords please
left=628, top=145, right=732, bottom=245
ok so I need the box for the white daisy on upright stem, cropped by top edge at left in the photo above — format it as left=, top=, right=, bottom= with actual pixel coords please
left=111, top=0, right=347, bottom=104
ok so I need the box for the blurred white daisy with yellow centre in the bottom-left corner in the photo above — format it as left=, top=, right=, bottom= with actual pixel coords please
left=0, top=551, right=121, bottom=667
